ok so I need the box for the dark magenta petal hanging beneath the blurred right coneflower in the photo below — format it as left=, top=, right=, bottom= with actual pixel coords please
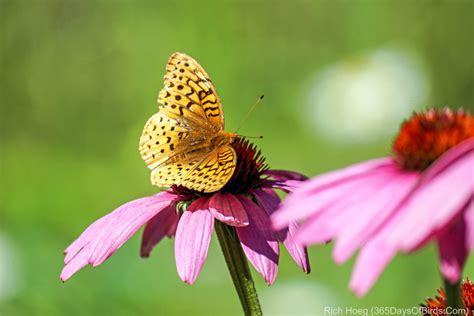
left=437, top=206, right=469, bottom=283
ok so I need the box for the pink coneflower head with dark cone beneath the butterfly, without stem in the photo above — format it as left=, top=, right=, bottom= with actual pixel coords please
left=61, top=140, right=310, bottom=284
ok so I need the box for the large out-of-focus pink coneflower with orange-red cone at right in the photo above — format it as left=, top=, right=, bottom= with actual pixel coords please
left=272, top=109, right=474, bottom=296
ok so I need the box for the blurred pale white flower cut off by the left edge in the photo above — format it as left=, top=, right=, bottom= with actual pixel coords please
left=0, top=233, right=18, bottom=301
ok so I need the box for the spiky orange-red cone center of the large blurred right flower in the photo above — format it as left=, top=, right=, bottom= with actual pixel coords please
left=393, top=108, right=474, bottom=171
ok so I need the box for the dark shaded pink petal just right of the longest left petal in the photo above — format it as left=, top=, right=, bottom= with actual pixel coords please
left=140, top=205, right=179, bottom=257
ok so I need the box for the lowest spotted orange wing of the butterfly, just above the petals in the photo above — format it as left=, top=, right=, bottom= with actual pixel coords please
left=151, top=146, right=237, bottom=192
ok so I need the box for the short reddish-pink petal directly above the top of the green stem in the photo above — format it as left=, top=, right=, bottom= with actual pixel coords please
left=209, top=192, right=249, bottom=226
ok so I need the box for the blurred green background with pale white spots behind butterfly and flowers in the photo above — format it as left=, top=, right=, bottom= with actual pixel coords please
left=0, top=0, right=474, bottom=315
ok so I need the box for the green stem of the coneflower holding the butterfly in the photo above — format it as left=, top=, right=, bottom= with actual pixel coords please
left=215, top=221, right=262, bottom=315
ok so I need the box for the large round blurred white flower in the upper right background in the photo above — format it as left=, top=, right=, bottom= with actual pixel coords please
left=301, top=49, right=428, bottom=142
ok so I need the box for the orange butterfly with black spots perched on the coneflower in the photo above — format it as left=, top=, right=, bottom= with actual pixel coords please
left=139, top=53, right=238, bottom=192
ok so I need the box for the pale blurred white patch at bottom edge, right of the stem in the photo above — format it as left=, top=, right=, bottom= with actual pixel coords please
left=259, top=281, right=341, bottom=316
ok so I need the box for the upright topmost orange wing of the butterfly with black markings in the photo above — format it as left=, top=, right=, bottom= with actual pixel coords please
left=158, top=53, right=224, bottom=132
